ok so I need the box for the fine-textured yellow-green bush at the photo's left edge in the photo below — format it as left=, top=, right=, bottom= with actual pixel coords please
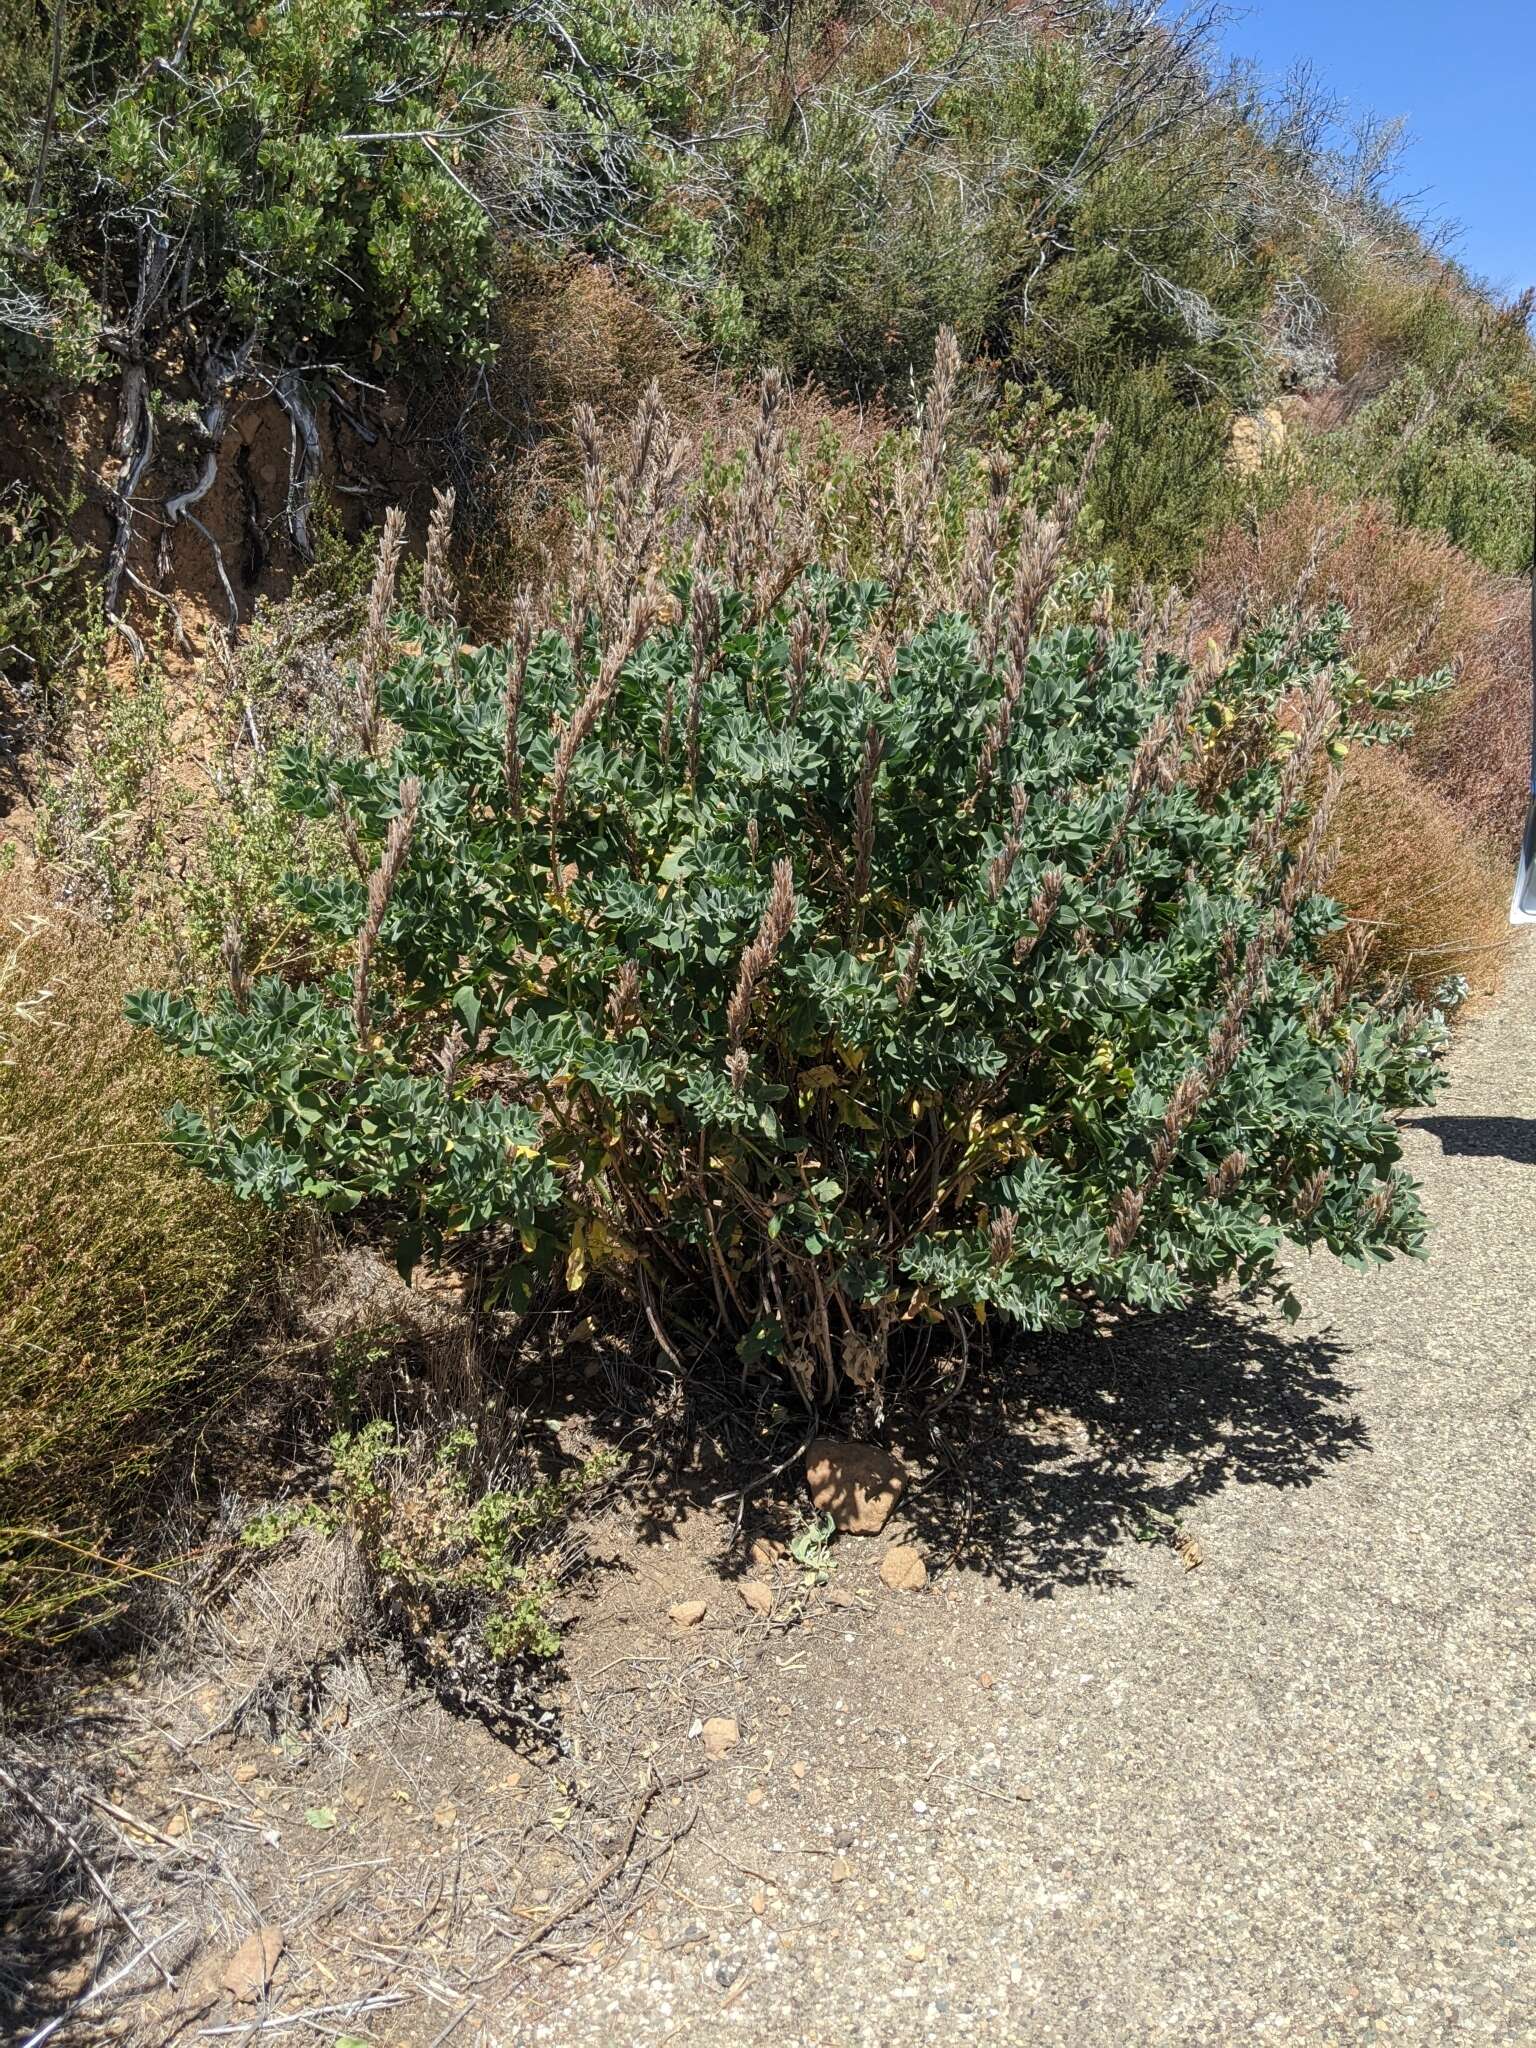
left=0, top=872, right=270, bottom=1647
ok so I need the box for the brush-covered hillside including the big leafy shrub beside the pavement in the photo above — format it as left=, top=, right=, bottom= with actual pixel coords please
left=0, top=0, right=1536, bottom=1638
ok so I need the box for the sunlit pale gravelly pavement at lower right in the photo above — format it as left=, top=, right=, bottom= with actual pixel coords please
left=524, top=946, right=1536, bottom=2048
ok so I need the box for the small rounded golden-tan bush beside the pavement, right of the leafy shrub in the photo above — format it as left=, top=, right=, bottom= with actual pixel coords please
left=1329, top=748, right=1509, bottom=999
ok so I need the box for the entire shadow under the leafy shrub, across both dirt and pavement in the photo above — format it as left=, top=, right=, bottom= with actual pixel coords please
left=565, top=1300, right=1368, bottom=1597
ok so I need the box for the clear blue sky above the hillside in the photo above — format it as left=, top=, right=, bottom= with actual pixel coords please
left=1223, top=0, right=1536, bottom=293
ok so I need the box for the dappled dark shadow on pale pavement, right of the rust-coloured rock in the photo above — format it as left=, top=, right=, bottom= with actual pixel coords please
left=905, top=1307, right=1368, bottom=1597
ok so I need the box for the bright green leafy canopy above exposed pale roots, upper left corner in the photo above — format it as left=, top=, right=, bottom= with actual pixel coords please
left=0, top=0, right=496, bottom=385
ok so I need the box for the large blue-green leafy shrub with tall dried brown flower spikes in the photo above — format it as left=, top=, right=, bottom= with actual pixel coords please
left=133, top=354, right=1440, bottom=1399
